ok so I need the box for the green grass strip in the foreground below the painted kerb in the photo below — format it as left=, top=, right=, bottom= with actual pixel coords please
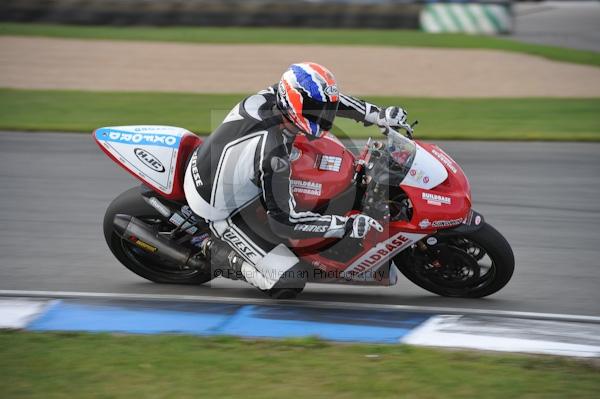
left=0, top=332, right=600, bottom=399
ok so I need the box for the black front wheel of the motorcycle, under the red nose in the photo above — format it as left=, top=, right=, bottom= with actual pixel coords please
left=394, top=223, right=515, bottom=298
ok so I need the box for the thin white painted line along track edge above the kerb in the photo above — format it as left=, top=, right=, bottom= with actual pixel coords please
left=0, top=290, right=600, bottom=323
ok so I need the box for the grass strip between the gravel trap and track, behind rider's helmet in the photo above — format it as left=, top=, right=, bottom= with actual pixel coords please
left=0, top=89, right=600, bottom=141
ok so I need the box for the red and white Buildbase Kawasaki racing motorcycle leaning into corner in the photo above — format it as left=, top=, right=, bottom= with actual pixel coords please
left=93, top=125, right=514, bottom=298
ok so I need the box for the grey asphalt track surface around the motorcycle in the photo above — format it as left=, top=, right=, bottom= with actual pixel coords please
left=0, top=132, right=600, bottom=316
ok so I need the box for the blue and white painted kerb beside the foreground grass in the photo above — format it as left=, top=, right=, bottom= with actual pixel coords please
left=0, top=298, right=600, bottom=357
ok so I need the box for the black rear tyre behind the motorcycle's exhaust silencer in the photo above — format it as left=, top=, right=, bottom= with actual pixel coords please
left=103, top=186, right=212, bottom=284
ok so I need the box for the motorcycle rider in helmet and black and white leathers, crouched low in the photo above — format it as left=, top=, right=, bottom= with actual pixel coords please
left=184, top=62, right=410, bottom=298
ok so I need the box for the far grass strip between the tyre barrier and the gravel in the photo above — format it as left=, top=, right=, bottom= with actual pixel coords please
left=0, top=23, right=600, bottom=66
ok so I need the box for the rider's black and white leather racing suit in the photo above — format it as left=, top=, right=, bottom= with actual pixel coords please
left=184, top=86, right=380, bottom=289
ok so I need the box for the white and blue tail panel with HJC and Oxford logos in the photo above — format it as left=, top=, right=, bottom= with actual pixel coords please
left=95, top=126, right=188, bottom=194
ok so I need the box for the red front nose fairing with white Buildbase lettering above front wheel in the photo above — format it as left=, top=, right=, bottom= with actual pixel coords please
left=392, top=142, right=471, bottom=234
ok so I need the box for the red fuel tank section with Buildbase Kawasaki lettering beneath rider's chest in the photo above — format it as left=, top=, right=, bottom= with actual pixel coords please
left=290, top=133, right=354, bottom=209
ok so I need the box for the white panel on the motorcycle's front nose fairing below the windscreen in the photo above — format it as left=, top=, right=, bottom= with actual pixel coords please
left=400, top=144, right=448, bottom=190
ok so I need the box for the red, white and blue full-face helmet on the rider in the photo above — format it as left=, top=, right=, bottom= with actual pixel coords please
left=277, top=62, right=340, bottom=137
